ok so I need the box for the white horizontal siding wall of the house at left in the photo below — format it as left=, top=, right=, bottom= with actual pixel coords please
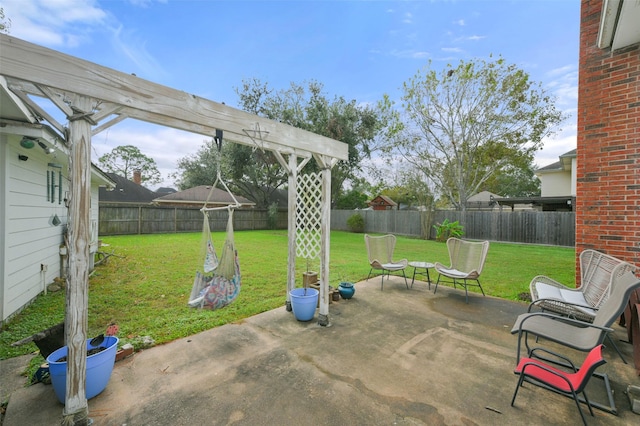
left=2, top=138, right=69, bottom=321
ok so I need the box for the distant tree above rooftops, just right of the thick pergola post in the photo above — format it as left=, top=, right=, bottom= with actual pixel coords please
left=98, top=145, right=161, bottom=184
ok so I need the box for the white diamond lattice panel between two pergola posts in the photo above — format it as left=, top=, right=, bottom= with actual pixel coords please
left=296, top=173, right=322, bottom=260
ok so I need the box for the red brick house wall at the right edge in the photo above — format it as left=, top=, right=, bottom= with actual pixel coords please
left=576, top=0, right=640, bottom=276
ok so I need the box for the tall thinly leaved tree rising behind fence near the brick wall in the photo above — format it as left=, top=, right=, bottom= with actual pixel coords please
left=381, top=58, right=564, bottom=210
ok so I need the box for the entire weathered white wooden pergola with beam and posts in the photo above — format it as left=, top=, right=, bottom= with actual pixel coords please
left=0, top=34, right=348, bottom=424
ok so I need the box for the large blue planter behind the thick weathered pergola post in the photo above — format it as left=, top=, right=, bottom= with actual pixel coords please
left=47, top=336, right=118, bottom=404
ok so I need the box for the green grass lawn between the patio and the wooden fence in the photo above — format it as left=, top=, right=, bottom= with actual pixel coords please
left=0, top=231, right=575, bottom=359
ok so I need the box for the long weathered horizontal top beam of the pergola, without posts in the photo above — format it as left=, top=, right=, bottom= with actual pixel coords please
left=0, top=34, right=349, bottom=160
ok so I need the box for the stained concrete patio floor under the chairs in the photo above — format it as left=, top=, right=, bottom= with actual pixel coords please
left=4, top=277, right=640, bottom=426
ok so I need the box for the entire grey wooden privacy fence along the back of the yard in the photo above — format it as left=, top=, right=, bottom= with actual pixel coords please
left=99, top=205, right=575, bottom=247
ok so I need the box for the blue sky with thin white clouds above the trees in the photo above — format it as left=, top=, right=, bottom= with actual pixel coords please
left=0, top=0, right=580, bottom=189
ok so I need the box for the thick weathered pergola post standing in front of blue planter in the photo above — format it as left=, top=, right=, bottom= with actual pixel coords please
left=62, top=95, right=92, bottom=426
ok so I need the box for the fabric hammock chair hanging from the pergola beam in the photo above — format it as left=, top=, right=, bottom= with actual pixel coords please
left=188, top=132, right=241, bottom=310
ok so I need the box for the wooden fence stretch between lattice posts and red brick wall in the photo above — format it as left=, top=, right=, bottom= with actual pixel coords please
left=331, top=210, right=575, bottom=247
